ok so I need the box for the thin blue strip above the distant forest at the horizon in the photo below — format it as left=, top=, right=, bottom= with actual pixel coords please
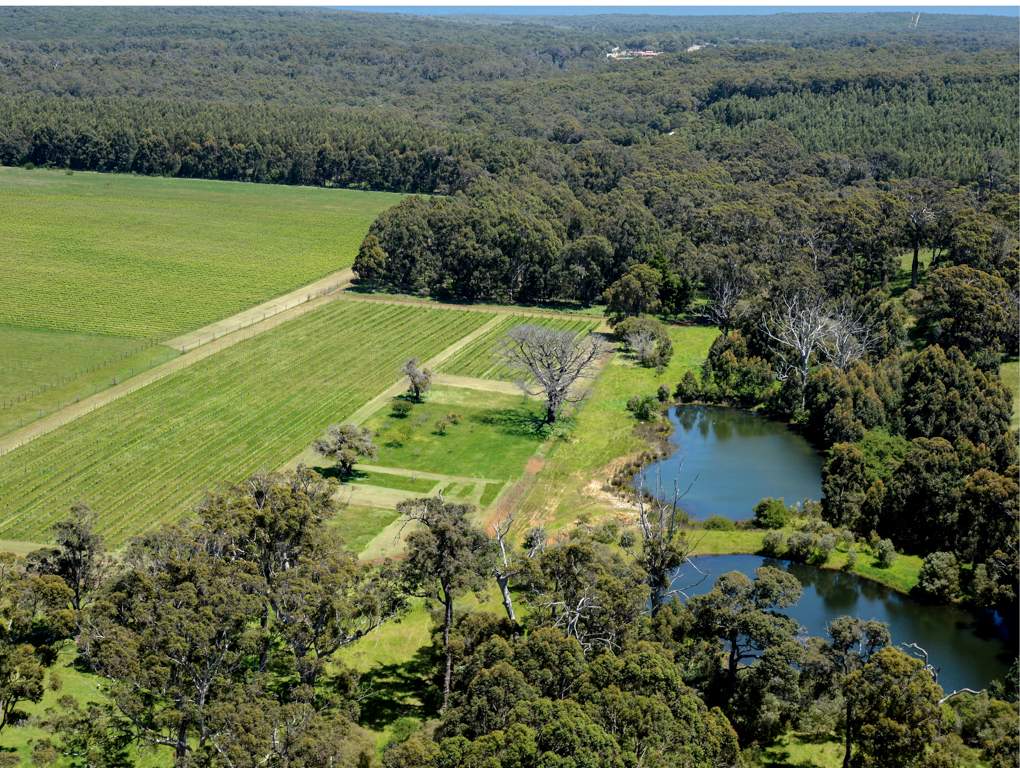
left=334, top=4, right=1020, bottom=17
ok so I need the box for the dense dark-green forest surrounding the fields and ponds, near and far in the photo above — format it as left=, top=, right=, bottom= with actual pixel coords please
left=0, top=8, right=1020, bottom=768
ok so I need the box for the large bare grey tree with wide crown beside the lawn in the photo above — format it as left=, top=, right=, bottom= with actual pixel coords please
left=496, top=324, right=609, bottom=424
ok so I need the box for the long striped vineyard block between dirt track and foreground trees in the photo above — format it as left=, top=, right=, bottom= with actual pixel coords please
left=0, top=301, right=489, bottom=546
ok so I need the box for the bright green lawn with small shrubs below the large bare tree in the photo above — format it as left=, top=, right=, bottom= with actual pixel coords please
left=364, top=383, right=548, bottom=479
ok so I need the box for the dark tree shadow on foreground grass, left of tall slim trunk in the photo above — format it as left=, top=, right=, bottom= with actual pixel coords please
left=360, top=648, right=440, bottom=730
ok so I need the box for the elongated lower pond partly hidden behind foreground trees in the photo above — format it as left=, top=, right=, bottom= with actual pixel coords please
left=673, top=555, right=1017, bottom=693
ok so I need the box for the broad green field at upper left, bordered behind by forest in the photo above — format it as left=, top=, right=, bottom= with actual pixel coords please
left=0, top=168, right=401, bottom=341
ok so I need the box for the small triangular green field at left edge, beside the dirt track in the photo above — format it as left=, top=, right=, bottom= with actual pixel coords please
left=0, top=327, right=180, bottom=434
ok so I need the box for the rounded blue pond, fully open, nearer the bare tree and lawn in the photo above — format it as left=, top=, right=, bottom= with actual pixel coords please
left=635, top=405, right=823, bottom=520
